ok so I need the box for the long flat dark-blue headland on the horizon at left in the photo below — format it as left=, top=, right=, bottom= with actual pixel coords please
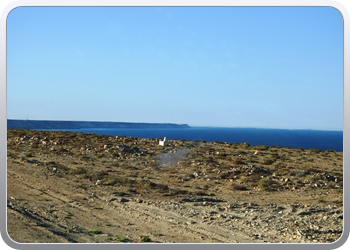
left=7, top=119, right=190, bottom=129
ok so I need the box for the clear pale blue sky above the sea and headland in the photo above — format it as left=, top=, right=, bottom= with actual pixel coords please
left=7, top=7, right=343, bottom=130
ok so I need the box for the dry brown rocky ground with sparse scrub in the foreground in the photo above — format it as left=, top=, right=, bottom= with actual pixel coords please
left=7, top=130, right=343, bottom=244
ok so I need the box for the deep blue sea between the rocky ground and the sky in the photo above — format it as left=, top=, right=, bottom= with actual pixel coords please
left=38, top=127, right=343, bottom=152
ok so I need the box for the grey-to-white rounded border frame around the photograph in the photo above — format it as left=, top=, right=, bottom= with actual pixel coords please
left=0, top=0, right=350, bottom=250
